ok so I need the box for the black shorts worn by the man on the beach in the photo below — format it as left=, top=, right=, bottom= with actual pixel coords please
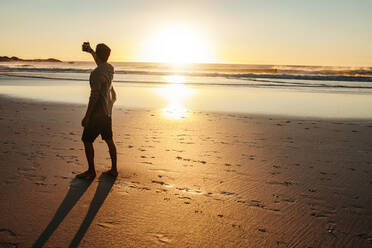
left=81, top=116, right=112, bottom=143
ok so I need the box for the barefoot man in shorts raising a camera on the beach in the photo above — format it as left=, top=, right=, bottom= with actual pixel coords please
left=76, top=42, right=118, bottom=180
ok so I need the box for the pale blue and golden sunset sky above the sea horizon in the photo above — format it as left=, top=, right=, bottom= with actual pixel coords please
left=0, top=0, right=372, bottom=66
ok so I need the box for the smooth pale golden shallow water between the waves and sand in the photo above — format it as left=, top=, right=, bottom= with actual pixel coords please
left=0, top=73, right=372, bottom=120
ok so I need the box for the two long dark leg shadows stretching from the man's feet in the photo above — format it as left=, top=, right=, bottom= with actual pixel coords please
left=32, top=175, right=115, bottom=248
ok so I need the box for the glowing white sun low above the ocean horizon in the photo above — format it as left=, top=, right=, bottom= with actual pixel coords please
left=142, top=25, right=213, bottom=64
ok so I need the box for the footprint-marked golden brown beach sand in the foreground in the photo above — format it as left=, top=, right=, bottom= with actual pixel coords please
left=0, top=94, right=372, bottom=247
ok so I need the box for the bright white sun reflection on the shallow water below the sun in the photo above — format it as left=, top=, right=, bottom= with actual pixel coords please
left=156, top=75, right=194, bottom=120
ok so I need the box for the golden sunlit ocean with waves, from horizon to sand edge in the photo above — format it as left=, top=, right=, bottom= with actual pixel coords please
left=0, top=61, right=372, bottom=119
